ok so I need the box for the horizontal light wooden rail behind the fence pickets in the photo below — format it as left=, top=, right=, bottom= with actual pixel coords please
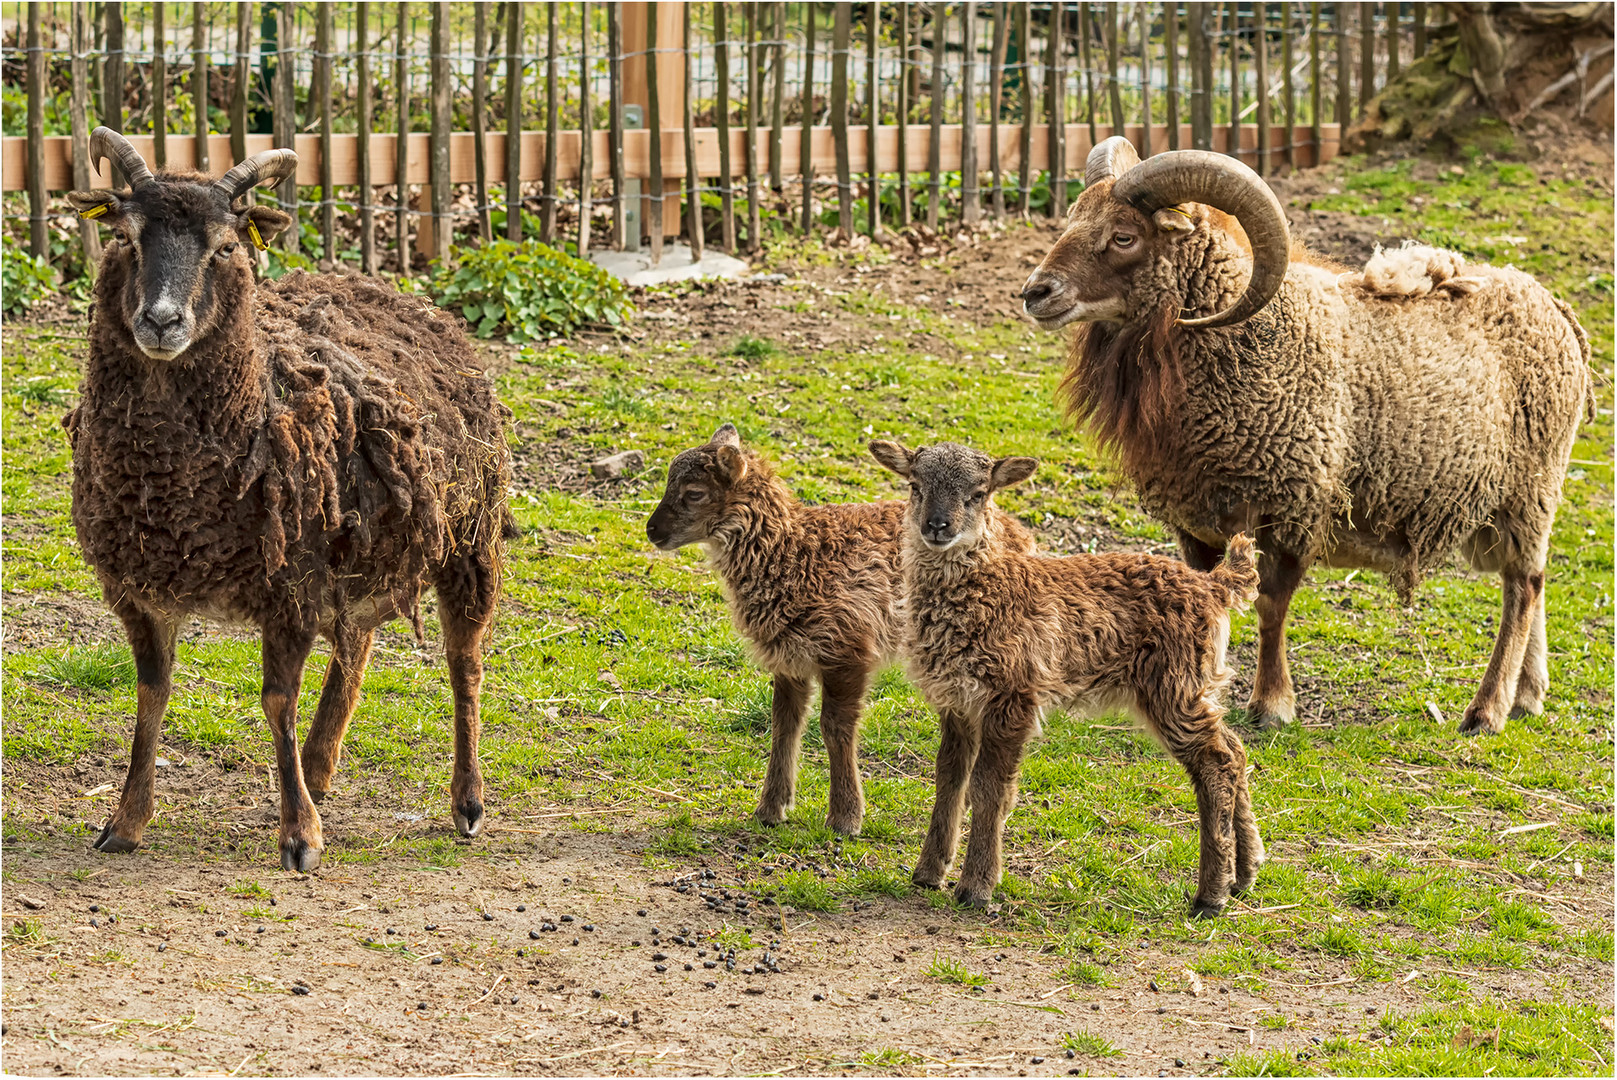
left=0, top=123, right=1340, bottom=191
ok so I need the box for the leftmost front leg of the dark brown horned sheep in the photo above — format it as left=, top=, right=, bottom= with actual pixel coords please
left=95, top=600, right=179, bottom=852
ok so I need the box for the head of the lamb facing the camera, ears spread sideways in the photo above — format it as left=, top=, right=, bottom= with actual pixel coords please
left=870, top=440, right=1038, bottom=551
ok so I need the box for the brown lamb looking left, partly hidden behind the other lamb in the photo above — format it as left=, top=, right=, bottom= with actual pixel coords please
left=645, top=424, right=1032, bottom=836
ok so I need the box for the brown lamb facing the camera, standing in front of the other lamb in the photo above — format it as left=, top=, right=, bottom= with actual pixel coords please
left=870, top=441, right=1263, bottom=918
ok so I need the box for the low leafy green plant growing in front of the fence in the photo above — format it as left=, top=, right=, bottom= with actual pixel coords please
left=429, top=239, right=634, bottom=341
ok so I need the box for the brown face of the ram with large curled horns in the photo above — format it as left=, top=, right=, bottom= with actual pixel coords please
left=1022, top=179, right=1195, bottom=330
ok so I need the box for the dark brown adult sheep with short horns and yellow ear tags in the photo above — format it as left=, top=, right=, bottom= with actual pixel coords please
left=63, top=128, right=513, bottom=871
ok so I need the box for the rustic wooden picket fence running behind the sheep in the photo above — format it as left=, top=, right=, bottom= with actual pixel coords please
left=0, top=2, right=1452, bottom=272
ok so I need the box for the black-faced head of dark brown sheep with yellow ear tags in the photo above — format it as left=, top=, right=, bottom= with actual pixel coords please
left=68, top=175, right=291, bottom=361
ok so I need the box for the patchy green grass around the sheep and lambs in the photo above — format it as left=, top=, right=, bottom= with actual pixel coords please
left=0, top=147, right=1612, bottom=1075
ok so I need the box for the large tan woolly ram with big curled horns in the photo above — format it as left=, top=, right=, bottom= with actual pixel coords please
left=1022, top=137, right=1593, bottom=734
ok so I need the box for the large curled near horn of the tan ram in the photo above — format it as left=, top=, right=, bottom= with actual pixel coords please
left=1096, top=148, right=1290, bottom=327
